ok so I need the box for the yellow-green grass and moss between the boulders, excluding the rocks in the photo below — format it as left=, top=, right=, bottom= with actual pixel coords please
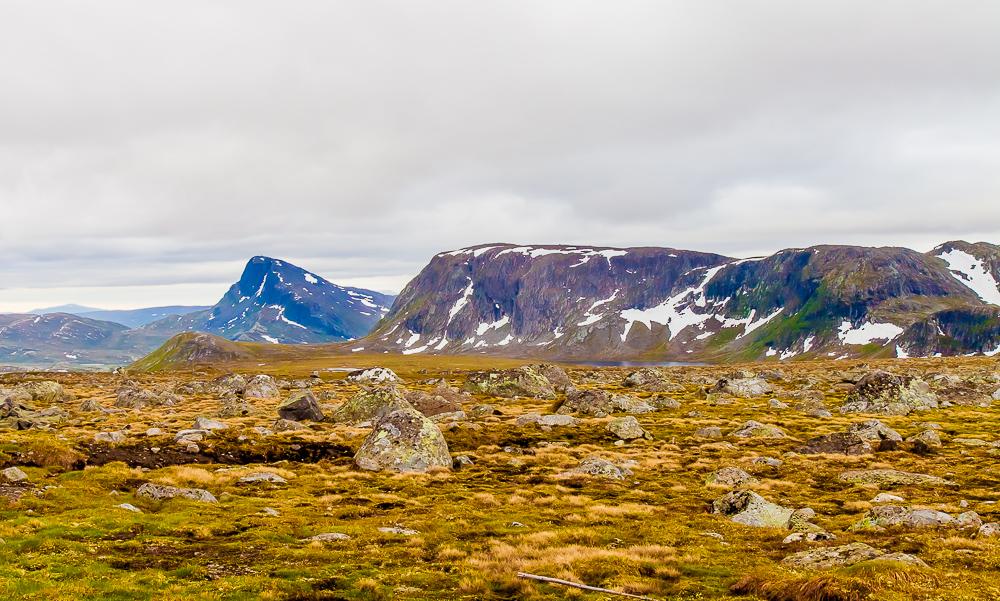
left=0, top=349, right=1000, bottom=601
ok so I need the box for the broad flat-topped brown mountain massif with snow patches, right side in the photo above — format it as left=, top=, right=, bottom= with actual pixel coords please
left=364, top=241, right=1000, bottom=361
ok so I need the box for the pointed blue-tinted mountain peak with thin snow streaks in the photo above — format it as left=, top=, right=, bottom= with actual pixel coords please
left=139, top=257, right=394, bottom=344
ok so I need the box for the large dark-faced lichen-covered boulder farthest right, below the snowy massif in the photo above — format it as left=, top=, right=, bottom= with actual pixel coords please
left=840, top=370, right=938, bottom=415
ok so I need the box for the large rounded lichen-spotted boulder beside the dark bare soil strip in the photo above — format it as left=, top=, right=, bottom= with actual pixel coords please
left=354, top=408, right=452, bottom=472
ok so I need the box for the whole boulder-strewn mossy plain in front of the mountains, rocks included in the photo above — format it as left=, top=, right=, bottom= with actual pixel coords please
left=0, top=356, right=1000, bottom=601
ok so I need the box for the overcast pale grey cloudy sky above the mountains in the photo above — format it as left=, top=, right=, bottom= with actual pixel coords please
left=0, top=0, right=1000, bottom=312
